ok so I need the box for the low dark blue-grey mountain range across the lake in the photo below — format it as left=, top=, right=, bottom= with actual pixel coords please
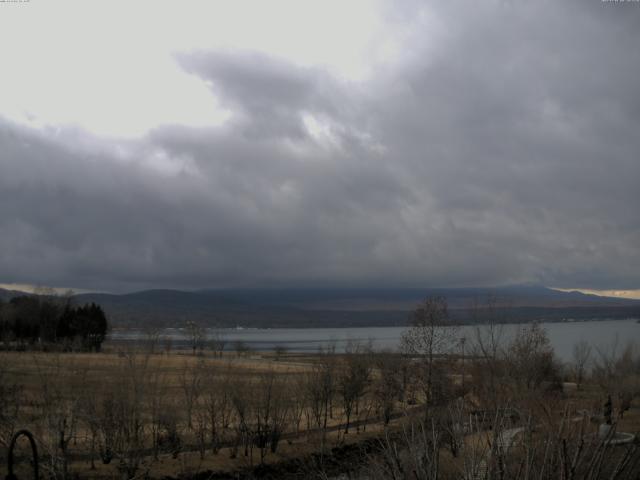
left=0, top=286, right=640, bottom=328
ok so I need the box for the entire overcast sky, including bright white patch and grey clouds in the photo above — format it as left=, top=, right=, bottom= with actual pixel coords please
left=0, top=0, right=640, bottom=291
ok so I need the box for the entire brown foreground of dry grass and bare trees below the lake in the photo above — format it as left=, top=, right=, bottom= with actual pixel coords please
left=0, top=330, right=640, bottom=480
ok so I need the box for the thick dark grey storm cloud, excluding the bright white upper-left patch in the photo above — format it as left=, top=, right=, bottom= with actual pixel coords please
left=0, top=1, right=640, bottom=291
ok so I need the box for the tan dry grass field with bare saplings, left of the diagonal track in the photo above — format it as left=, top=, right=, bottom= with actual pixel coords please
left=0, top=351, right=418, bottom=478
